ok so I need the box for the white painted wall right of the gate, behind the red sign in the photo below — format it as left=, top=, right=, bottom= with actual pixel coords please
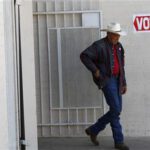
left=100, top=0, right=150, bottom=136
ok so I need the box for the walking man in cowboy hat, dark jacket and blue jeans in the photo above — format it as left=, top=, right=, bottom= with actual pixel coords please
left=80, top=23, right=129, bottom=150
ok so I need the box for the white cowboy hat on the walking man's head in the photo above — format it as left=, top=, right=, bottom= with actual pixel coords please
left=100, top=22, right=127, bottom=36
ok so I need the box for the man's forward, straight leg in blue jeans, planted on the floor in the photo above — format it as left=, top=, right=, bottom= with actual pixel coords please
left=103, top=78, right=124, bottom=143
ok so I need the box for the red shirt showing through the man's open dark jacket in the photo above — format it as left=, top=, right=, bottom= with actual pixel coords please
left=112, top=46, right=119, bottom=75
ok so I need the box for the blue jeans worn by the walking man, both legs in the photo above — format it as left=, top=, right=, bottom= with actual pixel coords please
left=89, top=77, right=124, bottom=143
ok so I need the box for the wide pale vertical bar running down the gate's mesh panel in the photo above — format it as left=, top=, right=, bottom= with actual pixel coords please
left=57, top=29, right=63, bottom=108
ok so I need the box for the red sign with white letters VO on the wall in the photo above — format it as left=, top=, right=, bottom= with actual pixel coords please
left=133, top=15, right=150, bottom=32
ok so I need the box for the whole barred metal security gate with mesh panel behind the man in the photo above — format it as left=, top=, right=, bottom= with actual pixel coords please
left=33, top=0, right=103, bottom=137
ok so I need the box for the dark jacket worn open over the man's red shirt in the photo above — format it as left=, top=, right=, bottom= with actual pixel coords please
left=80, top=37, right=126, bottom=89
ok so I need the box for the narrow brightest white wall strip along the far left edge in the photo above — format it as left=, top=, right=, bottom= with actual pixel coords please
left=0, top=1, right=9, bottom=150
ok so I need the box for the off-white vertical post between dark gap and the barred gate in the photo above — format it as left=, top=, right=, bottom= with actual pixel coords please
left=20, top=0, right=37, bottom=150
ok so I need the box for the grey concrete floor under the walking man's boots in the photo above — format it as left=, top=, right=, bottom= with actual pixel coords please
left=39, top=137, right=150, bottom=150
